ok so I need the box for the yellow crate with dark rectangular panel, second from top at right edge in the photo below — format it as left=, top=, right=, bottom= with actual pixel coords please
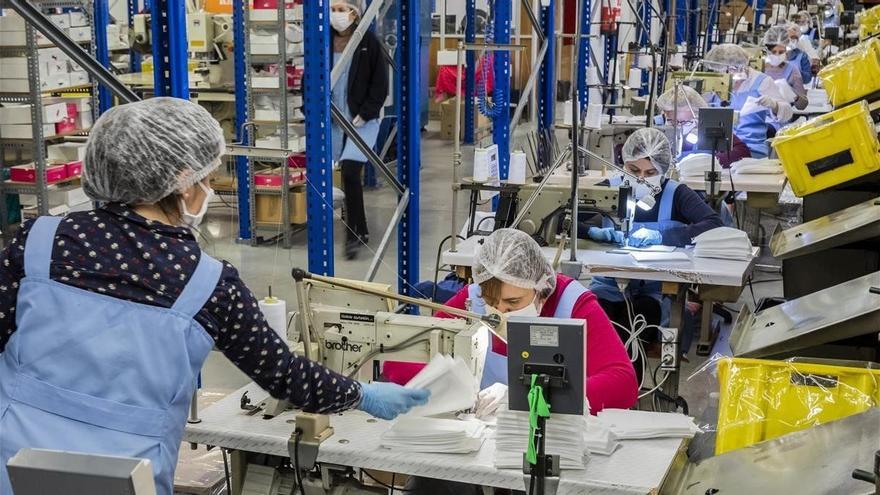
left=772, top=101, right=880, bottom=196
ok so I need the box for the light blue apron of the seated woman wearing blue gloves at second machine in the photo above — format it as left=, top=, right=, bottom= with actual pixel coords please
left=590, top=180, right=685, bottom=324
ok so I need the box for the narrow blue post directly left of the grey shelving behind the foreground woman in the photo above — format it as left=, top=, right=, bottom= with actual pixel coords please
left=232, top=0, right=253, bottom=241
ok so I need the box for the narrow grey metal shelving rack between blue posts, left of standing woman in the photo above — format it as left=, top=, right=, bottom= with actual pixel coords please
left=242, top=0, right=302, bottom=249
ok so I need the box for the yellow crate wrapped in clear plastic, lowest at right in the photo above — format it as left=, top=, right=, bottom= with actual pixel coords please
left=715, top=358, right=880, bottom=455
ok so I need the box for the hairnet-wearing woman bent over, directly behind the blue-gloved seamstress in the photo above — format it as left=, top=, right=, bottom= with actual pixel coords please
left=657, top=84, right=752, bottom=168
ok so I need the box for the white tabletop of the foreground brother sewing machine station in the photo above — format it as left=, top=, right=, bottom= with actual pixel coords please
left=183, top=383, right=686, bottom=495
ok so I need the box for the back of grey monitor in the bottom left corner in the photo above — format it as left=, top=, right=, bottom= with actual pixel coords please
left=6, top=449, right=156, bottom=495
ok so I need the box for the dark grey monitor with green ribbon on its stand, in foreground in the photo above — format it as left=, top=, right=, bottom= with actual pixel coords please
left=507, top=317, right=587, bottom=415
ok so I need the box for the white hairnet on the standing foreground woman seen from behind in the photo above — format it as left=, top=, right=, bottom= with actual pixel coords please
left=82, top=97, right=226, bottom=204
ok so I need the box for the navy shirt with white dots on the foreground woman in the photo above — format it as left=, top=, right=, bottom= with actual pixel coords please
left=0, top=204, right=361, bottom=413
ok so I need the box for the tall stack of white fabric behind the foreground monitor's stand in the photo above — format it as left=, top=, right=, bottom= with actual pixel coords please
left=495, top=411, right=588, bottom=469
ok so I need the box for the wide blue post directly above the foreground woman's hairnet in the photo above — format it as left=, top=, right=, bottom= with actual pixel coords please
left=150, top=0, right=189, bottom=100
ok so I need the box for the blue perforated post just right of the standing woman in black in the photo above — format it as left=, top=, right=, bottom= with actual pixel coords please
left=394, top=0, right=422, bottom=306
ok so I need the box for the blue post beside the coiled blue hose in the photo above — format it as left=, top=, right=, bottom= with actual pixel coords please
left=492, top=0, right=511, bottom=180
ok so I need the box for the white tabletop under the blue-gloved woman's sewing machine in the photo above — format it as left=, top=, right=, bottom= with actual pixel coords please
left=440, top=236, right=759, bottom=287
